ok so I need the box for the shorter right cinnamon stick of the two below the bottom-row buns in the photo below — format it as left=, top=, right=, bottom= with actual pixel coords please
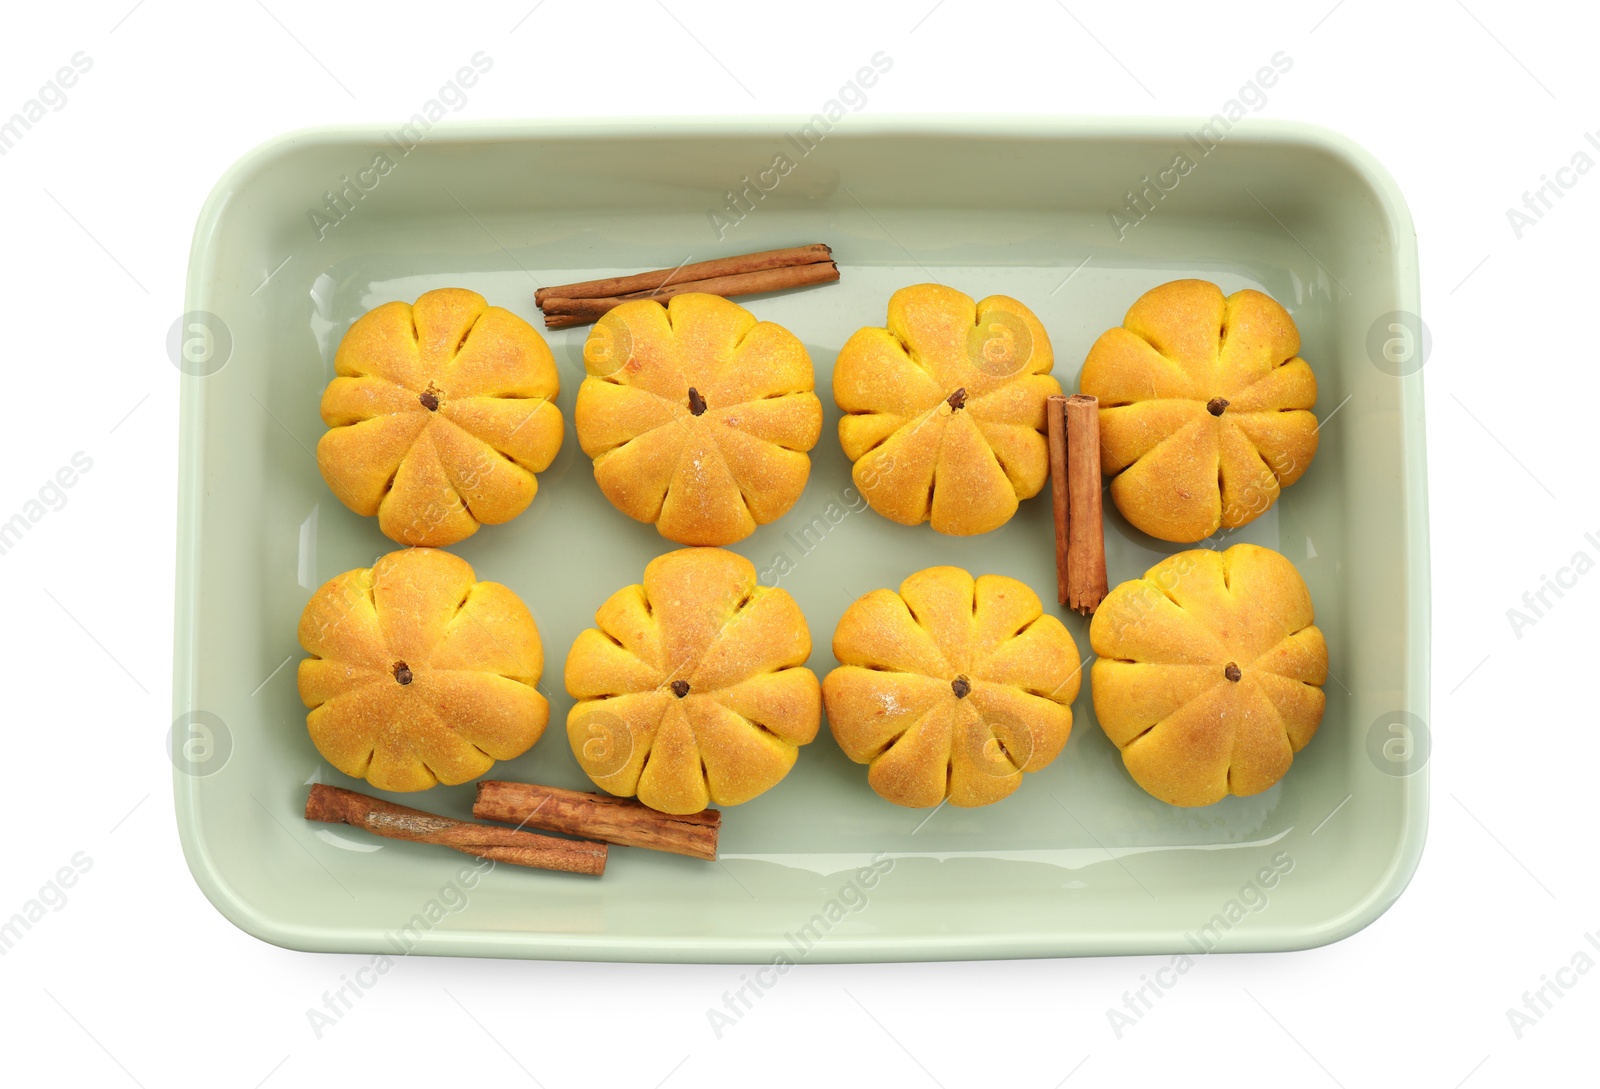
left=472, top=779, right=722, bottom=862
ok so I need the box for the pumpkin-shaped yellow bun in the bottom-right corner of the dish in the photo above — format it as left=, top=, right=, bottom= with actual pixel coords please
left=1090, top=544, right=1328, bottom=806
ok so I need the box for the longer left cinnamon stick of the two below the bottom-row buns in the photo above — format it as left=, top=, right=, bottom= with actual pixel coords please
left=306, top=784, right=606, bottom=876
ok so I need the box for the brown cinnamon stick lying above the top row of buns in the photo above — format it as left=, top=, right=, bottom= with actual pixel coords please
left=533, top=241, right=838, bottom=329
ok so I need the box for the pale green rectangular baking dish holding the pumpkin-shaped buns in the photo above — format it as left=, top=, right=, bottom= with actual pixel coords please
left=171, top=115, right=1429, bottom=963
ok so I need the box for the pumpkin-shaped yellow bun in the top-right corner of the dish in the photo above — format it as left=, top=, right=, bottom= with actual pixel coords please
left=1080, top=280, right=1318, bottom=542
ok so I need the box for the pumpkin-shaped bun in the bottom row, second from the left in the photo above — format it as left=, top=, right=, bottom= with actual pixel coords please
left=566, top=546, right=822, bottom=814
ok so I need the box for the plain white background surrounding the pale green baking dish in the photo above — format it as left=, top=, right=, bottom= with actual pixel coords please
left=0, top=0, right=1600, bottom=1089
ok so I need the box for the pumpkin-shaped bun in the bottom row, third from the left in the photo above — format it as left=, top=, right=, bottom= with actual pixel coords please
left=822, top=568, right=1080, bottom=806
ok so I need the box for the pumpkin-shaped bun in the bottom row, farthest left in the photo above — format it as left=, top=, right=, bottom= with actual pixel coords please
left=299, top=548, right=550, bottom=790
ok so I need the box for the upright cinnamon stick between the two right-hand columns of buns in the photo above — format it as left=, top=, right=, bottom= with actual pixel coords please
left=1045, top=393, right=1107, bottom=616
